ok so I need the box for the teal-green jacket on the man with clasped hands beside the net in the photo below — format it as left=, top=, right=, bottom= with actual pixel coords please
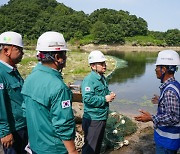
left=81, top=71, right=110, bottom=120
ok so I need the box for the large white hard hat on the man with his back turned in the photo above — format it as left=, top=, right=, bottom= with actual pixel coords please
left=36, top=31, right=68, bottom=51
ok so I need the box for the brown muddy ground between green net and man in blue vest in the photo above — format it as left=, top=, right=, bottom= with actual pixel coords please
left=105, top=114, right=155, bottom=154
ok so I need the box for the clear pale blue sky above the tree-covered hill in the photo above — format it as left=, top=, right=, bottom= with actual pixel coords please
left=0, top=0, right=180, bottom=32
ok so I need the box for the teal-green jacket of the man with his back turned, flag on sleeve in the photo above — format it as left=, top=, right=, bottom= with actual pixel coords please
left=22, top=63, right=75, bottom=154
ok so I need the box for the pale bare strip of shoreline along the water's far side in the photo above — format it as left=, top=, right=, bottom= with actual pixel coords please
left=68, top=44, right=180, bottom=52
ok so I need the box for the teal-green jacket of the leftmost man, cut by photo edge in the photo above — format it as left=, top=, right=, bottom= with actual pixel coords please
left=0, top=61, right=26, bottom=138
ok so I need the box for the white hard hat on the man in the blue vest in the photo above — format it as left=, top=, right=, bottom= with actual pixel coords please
left=155, top=50, right=180, bottom=65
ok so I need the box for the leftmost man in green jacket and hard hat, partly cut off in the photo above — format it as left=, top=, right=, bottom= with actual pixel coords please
left=0, top=32, right=28, bottom=154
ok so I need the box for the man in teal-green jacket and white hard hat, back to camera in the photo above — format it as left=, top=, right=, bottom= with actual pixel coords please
left=22, top=31, right=77, bottom=154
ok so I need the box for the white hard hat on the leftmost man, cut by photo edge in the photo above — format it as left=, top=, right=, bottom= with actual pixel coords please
left=0, top=31, right=23, bottom=47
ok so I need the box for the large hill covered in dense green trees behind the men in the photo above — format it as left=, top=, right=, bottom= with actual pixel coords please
left=0, top=0, right=180, bottom=44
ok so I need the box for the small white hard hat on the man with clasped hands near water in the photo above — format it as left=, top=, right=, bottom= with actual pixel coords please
left=88, top=50, right=106, bottom=64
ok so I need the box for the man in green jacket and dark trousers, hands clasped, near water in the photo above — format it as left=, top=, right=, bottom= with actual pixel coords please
left=82, top=50, right=116, bottom=154
